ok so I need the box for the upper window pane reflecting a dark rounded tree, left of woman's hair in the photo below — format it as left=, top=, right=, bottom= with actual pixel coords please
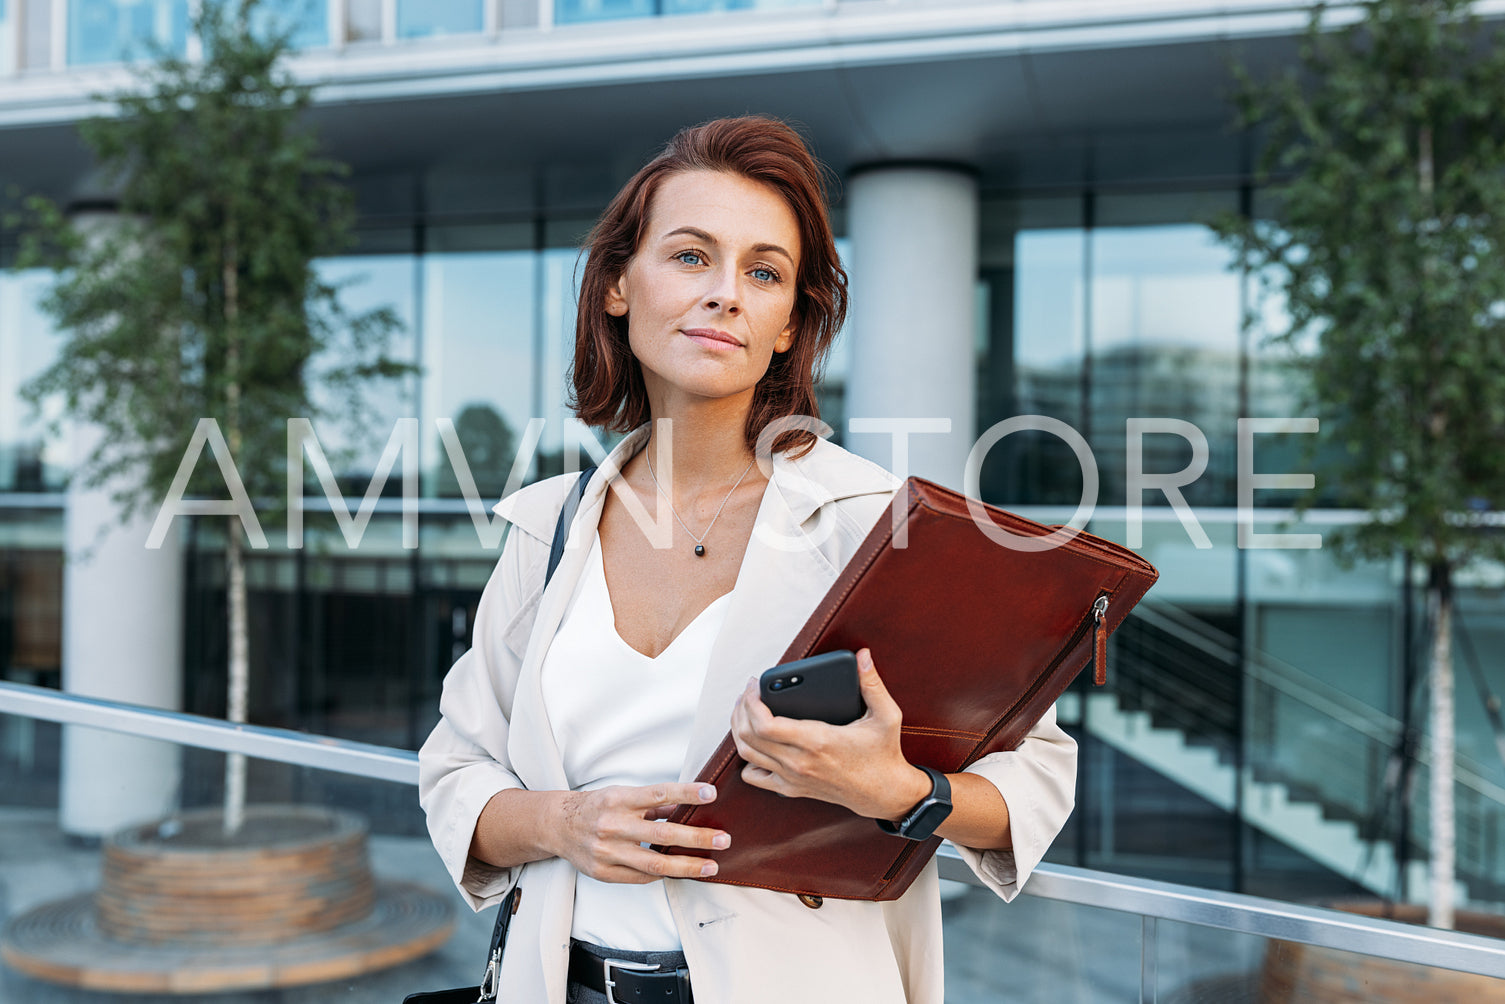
left=421, top=224, right=539, bottom=507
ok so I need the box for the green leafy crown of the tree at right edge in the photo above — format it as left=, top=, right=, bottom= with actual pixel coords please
left=1218, top=0, right=1505, bottom=564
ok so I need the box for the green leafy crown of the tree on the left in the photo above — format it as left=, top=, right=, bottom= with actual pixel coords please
left=21, top=0, right=414, bottom=526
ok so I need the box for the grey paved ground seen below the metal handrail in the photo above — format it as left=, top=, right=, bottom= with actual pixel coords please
left=0, top=808, right=1261, bottom=1004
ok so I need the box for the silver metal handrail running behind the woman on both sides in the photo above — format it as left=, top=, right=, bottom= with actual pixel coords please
left=0, top=683, right=1505, bottom=987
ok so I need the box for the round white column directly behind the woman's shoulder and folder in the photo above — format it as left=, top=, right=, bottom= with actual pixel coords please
left=846, top=166, right=978, bottom=488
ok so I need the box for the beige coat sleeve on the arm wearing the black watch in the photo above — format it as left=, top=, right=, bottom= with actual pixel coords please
left=957, top=704, right=1076, bottom=902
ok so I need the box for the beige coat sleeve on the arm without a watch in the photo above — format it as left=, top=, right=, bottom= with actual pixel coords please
left=418, top=527, right=542, bottom=911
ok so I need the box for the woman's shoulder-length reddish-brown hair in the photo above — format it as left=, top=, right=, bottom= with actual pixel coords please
left=572, top=116, right=847, bottom=453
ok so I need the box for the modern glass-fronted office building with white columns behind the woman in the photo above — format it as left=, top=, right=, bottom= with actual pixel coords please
left=0, top=0, right=1505, bottom=921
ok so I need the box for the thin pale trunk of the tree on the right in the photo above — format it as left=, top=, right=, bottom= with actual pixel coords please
left=1427, top=561, right=1457, bottom=929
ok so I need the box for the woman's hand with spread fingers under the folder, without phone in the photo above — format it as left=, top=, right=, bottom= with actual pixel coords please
left=552, top=783, right=731, bottom=884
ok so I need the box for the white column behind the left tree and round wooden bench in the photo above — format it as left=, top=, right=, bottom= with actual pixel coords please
left=59, top=214, right=184, bottom=837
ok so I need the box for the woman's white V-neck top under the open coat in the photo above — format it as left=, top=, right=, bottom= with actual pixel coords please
left=542, top=536, right=731, bottom=951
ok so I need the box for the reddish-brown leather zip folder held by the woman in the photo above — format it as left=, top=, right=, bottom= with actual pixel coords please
left=653, top=477, right=1159, bottom=900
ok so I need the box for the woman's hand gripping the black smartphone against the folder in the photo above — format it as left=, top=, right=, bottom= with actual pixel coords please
left=731, top=649, right=930, bottom=819
